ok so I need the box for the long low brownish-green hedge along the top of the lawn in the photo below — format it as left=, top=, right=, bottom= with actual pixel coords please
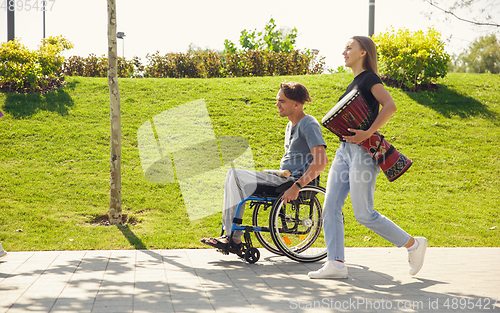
left=62, top=50, right=325, bottom=78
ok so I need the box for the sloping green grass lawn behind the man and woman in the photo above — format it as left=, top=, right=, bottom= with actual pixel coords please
left=0, top=74, right=500, bottom=251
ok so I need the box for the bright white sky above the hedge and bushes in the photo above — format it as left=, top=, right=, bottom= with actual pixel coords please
left=0, top=0, right=500, bottom=69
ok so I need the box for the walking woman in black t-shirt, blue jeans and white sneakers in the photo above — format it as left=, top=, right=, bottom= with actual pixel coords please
left=309, top=36, right=427, bottom=278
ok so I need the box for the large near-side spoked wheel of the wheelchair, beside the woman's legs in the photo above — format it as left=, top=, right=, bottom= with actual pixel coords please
left=269, top=186, right=326, bottom=262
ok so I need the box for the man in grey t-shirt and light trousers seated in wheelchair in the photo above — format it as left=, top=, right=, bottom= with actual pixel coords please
left=201, top=82, right=328, bottom=254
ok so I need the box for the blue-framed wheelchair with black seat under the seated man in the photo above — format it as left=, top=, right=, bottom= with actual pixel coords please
left=219, top=177, right=326, bottom=264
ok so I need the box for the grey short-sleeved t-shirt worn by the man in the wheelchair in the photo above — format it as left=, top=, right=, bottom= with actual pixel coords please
left=280, top=115, right=326, bottom=179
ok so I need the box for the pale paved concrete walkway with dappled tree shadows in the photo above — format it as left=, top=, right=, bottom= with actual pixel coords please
left=0, top=248, right=500, bottom=313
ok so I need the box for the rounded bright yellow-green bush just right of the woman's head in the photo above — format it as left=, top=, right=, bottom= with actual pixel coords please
left=373, top=27, right=450, bottom=90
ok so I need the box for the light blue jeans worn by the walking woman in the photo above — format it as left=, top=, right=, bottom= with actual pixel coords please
left=323, top=142, right=411, bottom=262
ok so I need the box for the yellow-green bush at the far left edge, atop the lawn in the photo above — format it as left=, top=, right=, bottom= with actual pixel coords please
left=0, top=37, right=73, bottom=93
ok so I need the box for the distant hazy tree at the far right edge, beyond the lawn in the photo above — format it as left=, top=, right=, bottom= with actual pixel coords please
left=454, top=34, right=500, bottom=74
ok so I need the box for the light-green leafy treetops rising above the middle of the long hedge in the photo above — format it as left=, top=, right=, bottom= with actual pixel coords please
left=224, top=18, right=297, bottom=53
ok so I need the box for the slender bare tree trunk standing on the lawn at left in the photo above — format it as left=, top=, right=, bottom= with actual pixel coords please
left=108, top=0, right=122, bottom=225
